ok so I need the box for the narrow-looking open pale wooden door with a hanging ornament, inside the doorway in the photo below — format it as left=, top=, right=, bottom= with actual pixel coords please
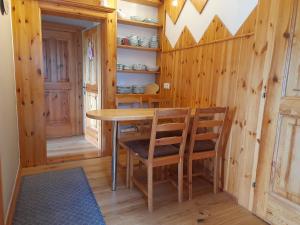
left=83, top=25, right=102, bottom=149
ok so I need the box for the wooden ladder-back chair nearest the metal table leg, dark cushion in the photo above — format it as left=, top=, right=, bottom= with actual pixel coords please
left=121, top=109, right=190, bottom=212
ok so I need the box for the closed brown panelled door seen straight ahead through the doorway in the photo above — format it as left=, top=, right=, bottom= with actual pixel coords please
left=43, top=25, right=82, bottom=138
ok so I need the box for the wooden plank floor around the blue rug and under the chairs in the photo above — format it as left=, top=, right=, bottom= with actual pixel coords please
left=22, top=157, right=266, bottom=225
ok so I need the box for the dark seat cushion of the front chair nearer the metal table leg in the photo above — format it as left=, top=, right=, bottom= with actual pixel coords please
left=124, top=140, right=179, bottom=159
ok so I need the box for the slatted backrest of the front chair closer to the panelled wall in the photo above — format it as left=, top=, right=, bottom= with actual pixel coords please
left=189, top=107, right=228, bottom=154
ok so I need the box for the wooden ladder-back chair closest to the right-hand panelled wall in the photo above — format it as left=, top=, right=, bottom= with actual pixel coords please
left=188, top=107, right=228, bottom=200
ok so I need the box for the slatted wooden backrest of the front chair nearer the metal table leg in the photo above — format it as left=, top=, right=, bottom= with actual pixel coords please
left=148, top=108, right=191, bottom=161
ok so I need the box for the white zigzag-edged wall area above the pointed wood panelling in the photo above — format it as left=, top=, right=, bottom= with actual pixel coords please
left=165, top=0, right=258, bottom=48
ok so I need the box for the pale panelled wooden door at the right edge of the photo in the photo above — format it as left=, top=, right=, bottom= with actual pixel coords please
left=254, top=0, right=300, bottom=225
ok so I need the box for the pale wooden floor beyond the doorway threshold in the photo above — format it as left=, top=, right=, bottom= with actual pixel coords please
left=47, top=136, right=99, bottom=157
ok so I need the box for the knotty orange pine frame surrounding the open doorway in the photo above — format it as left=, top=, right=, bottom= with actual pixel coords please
left=12, top=0, right=117, bottom=167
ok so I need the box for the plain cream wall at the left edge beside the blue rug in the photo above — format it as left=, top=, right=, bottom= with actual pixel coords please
left=0, top=0, right=20, bottom=221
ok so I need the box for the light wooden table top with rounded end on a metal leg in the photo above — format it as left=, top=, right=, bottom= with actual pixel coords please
left=86, top=108, right=194, bottom=121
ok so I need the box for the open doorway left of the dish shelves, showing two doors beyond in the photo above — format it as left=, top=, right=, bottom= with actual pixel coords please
left=42, top=15, right=102, bottom=162
